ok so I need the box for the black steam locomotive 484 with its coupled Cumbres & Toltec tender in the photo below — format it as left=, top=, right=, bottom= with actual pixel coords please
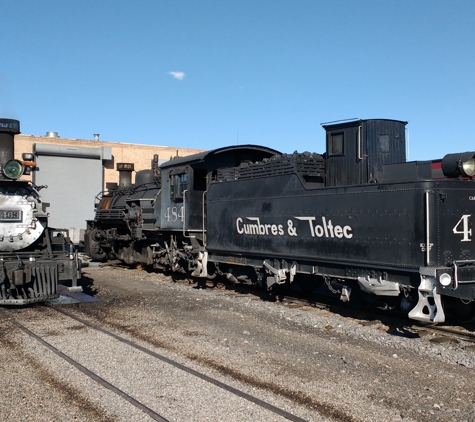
left=85, top=119, right=475, bottom=322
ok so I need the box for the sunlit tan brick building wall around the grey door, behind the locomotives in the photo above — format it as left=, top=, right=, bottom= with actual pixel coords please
left=15, top=134, right=204, bottom=189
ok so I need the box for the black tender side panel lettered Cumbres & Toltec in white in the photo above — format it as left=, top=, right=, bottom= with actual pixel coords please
left=207, top=175, right=434, bottom=268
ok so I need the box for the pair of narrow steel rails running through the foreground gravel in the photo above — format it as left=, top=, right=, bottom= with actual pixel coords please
left=0, top=306, right=310, bottom=422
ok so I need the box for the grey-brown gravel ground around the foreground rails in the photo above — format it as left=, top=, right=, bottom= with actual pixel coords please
left=0, top=267, right=475, bottom=422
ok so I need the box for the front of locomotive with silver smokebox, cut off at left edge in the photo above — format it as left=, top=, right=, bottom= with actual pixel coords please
left=0, top=119, right=81, bottom=305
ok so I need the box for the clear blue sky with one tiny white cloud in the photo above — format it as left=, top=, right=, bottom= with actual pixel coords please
left=0, top=0, right=475, bottom=160
